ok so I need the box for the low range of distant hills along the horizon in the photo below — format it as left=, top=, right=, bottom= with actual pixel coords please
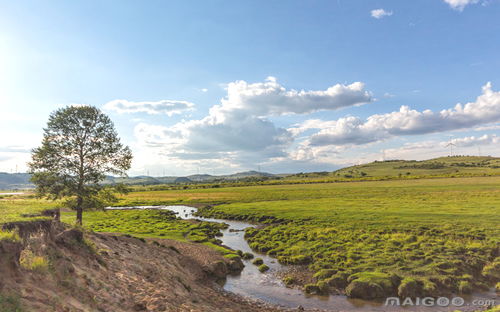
left=0, top=156, right=500, bottom=190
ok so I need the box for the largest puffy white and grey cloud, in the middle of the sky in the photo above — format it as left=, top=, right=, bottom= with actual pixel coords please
left=135, top=77, right=372, bottom=161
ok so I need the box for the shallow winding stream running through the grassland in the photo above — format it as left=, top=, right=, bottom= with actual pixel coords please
left=108, top=206, right=498, bottom=312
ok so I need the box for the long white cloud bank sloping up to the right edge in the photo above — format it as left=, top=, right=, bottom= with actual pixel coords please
left=306, top=83, right=500, bottom=146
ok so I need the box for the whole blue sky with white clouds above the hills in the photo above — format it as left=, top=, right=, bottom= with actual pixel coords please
left=0, top=0, right=500, bottom=176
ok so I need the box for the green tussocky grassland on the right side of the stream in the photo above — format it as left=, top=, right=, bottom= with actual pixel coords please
left=188, top=177, right=500, bottom=297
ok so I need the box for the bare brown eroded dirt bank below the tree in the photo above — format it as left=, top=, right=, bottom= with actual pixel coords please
left=0, top=221, right=302, bottom=311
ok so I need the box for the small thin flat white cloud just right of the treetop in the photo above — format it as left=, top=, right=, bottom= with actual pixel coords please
left=104, top=100, right=194, bottom=116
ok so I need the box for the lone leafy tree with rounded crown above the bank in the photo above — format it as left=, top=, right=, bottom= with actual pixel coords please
left=28, top=106, right=132, bottom=224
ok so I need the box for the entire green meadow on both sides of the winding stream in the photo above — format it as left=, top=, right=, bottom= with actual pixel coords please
left=0, top=176, right=500, bottom=299
